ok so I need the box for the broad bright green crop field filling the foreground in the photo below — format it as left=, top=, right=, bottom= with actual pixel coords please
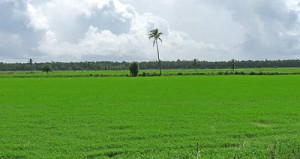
left=0, top=75, right=300, bottom=159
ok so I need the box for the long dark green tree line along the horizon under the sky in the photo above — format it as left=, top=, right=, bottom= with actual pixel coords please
left=0, top=59, right=300, bottom=71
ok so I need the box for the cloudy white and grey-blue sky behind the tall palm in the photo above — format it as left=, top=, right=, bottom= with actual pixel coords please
left=0, top=0, right=300, bottom=62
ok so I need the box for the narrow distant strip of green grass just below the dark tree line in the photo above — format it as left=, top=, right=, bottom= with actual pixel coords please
left=0, top=68, right=300, bottom=78
